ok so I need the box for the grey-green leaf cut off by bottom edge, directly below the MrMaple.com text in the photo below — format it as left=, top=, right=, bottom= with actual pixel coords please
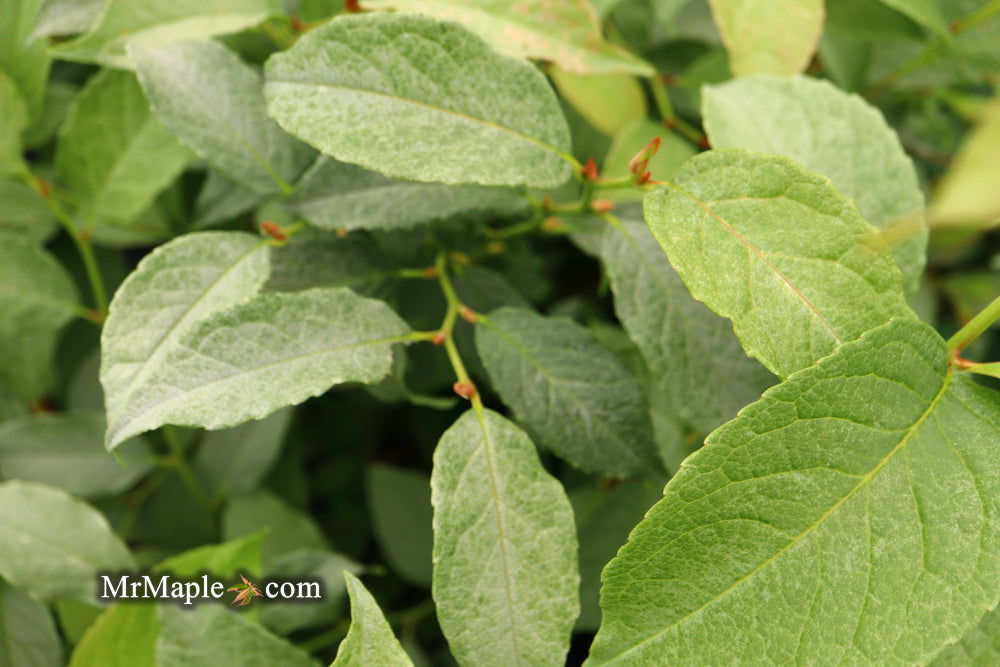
left=156, top=605, right=316, bottom=667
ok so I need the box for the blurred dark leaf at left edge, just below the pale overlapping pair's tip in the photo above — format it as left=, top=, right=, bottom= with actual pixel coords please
left=0, top=412, right=155, bottom=497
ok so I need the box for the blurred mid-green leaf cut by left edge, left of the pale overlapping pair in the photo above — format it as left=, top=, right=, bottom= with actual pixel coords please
left=0, top=235, right=82, bottom=399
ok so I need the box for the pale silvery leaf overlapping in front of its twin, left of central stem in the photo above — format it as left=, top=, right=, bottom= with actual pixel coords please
left=105, top=288, right=408, bottom=447
